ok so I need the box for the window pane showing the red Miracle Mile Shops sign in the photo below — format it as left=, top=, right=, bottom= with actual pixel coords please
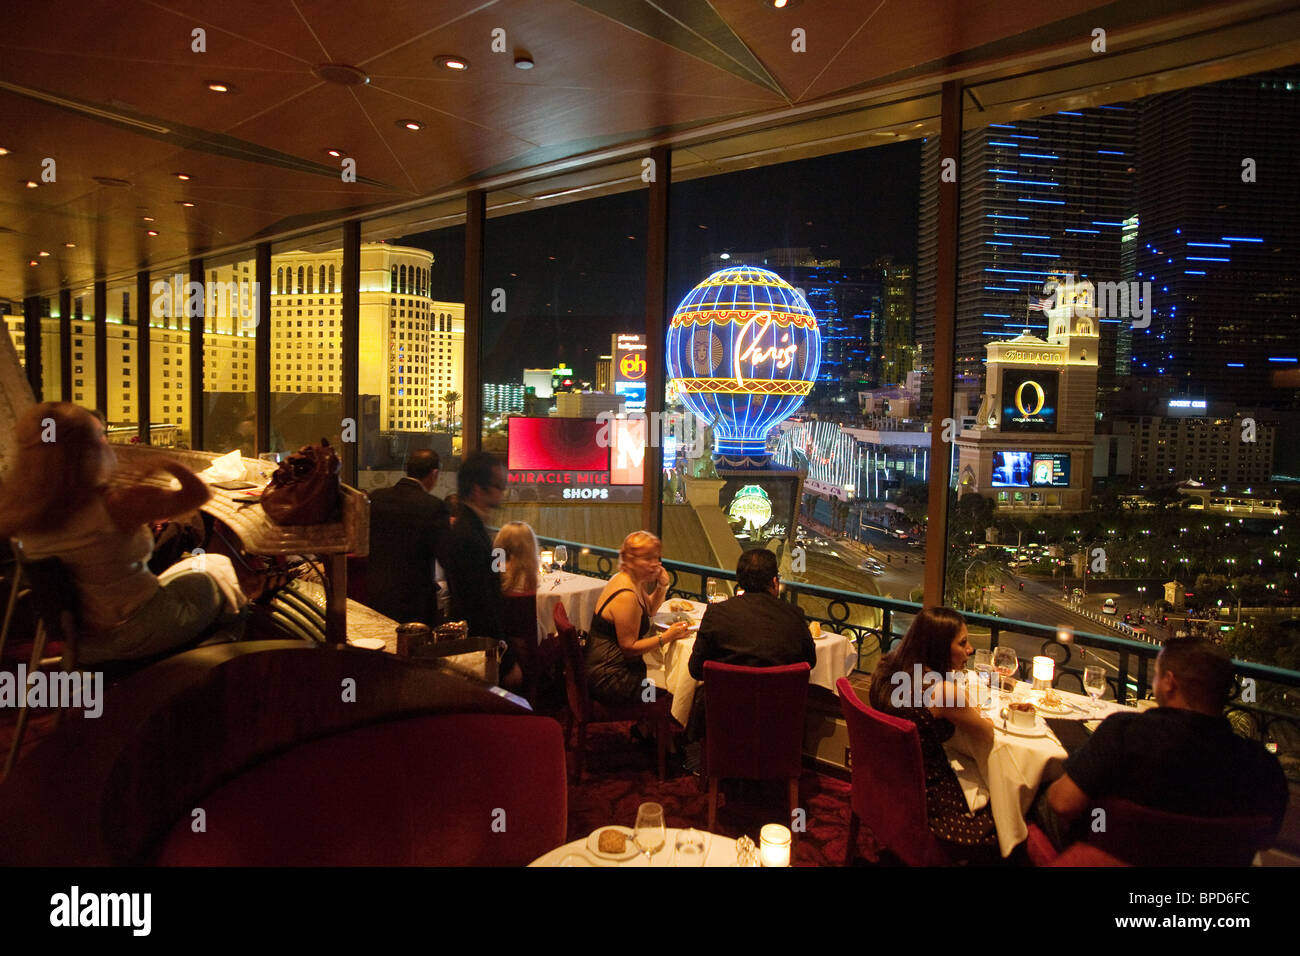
left=480, top=175, right=658, bottom=546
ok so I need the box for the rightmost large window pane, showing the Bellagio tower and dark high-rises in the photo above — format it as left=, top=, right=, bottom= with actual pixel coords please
left=946, top=68, right=1300, bottom=686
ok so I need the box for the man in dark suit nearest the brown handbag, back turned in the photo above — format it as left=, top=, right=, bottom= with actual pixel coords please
left=365, top=449, right=449, bottom=627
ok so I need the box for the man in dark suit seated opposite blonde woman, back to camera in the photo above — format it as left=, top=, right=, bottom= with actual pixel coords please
left=685, top=548, right=816, bottom=774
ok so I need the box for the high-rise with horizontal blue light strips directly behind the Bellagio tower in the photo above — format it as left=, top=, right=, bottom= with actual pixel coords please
left=917, top=105, right=1138, bottom=415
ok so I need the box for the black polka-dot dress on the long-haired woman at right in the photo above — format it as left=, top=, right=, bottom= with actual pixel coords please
left=871, top=671, right=998, bottom=862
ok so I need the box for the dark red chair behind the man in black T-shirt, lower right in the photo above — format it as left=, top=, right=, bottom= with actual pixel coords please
left=1028, top=800, right=1275, bottom=866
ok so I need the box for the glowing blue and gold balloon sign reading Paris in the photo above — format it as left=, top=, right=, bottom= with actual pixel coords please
left=666, top=265, right=822, bottom=470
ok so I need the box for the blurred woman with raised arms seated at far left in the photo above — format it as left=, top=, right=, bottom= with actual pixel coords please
left=0, top=402, right=244, bottom=665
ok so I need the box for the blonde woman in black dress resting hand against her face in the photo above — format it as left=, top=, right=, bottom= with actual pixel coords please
left=586, top=531, right=690, bottom=706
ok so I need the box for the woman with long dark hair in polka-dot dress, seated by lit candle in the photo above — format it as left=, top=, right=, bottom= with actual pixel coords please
left=871, top=607, right=998, bottom=862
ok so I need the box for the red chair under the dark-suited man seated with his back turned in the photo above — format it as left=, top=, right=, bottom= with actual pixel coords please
left=705, top=661, right=811, bottom=830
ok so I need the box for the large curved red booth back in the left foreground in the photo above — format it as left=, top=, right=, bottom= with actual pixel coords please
left=156, top=713, right=568, bottom=866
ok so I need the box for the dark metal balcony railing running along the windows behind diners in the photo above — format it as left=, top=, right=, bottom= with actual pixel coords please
left=538, top=535, right=1300, bottom=777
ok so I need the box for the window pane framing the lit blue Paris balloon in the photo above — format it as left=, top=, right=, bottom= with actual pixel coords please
left=663, top=142, right=930, bottom=666
